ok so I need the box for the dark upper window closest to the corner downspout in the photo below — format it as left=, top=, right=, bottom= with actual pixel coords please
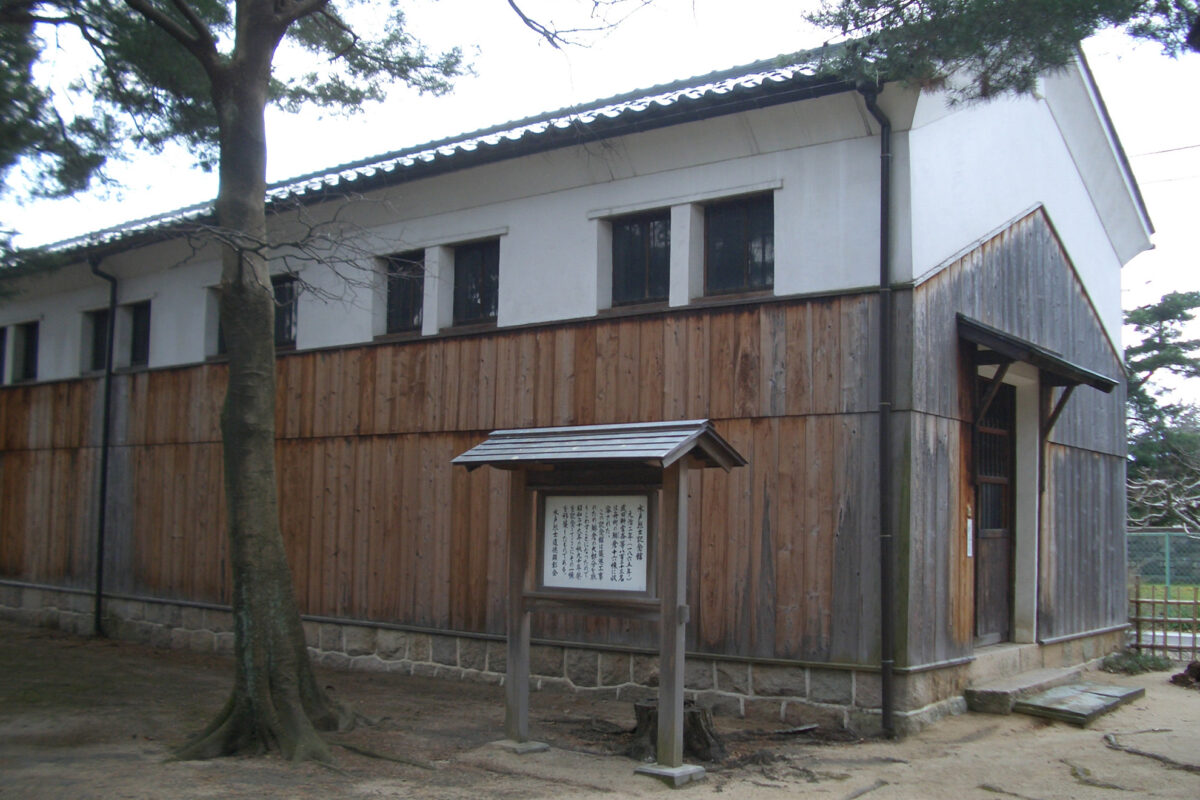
left=704, top=194, right=775, bottom=294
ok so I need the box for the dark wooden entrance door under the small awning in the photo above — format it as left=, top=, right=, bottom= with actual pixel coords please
left=974, top=380, right=1016, bottom=644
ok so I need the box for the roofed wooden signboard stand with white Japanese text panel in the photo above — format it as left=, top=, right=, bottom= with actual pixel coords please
left=454, top=420, right=746, bottom=787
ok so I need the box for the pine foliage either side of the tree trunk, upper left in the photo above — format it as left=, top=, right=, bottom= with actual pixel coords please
left=0, top=0, right=463, bottom=197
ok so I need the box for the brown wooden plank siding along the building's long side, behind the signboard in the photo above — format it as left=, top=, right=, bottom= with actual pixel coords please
left=0, top=295, right=878, bottom=664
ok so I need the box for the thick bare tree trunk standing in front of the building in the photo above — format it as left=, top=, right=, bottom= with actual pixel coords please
left=179, top=4, right=350, bottom=760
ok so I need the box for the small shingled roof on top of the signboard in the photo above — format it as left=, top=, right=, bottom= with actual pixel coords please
left=451, top=420, right=746, bottom=470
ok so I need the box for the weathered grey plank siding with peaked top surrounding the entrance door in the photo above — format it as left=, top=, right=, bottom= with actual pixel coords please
left=898, top=209, right=1126, bottom=664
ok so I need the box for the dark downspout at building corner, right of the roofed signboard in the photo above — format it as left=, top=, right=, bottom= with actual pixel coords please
left=858, top=86, right=895, bottom=736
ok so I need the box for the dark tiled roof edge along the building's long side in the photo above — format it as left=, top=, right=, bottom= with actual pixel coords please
left=46, top=50, right=850, bottom=254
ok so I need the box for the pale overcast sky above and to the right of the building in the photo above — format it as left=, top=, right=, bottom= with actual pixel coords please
left=0, top=0, right=1200, bottom=323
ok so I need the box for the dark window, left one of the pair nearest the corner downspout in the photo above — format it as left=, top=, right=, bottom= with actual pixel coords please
left=612, top=211, right=671, bottom=306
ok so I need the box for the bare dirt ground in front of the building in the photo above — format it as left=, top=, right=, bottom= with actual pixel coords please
left=0, top=622, right=1200, bottom=800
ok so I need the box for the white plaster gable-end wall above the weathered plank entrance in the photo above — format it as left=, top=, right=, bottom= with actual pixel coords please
left=908, top=66, right=1150, bottom=348
